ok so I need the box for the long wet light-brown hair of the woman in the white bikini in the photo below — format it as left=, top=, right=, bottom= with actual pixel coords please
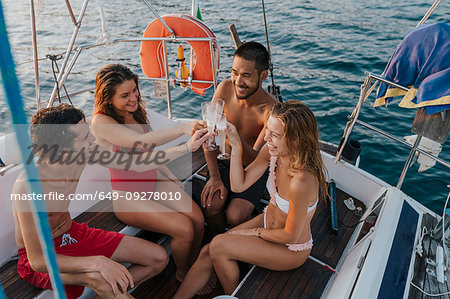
left=267, top=101, right=328, bottom=202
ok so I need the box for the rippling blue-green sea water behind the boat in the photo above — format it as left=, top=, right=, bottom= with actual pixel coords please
left=0, top=0, right=450, bottom=211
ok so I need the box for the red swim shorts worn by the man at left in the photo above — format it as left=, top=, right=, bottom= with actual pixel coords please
left=17, top=221, right=125, bottom=299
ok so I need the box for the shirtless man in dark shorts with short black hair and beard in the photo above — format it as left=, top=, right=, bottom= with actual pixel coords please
left=201, top=42, right=277, bottom=234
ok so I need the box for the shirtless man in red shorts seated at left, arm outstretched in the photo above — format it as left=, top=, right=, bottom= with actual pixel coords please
left=11, top=104, right=206, bottom=298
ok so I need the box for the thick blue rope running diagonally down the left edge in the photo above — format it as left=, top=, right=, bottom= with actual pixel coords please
left=0, top=0, right=66, bottom=299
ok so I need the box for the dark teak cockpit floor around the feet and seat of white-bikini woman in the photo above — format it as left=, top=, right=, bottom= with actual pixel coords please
left=132, top=189, right=365, bottom=298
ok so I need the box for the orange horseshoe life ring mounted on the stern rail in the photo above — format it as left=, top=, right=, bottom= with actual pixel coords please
left=140, top=14, right=220, bottom=94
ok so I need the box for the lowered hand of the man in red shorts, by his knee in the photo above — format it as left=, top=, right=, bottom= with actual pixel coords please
left=97, top=256, right=134, bottom=297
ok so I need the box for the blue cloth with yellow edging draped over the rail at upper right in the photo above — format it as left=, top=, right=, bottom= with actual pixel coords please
left=374, top=23, right=450, bottom=114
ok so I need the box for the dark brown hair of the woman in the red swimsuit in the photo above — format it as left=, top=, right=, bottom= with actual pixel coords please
left=94, top=64, right=148, bottom=124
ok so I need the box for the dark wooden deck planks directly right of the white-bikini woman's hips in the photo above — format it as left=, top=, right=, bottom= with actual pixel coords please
left=236, top=189, right=365, bottom=298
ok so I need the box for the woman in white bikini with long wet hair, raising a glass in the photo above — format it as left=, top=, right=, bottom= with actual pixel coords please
left=175, top=101, right=327, bottom=298
